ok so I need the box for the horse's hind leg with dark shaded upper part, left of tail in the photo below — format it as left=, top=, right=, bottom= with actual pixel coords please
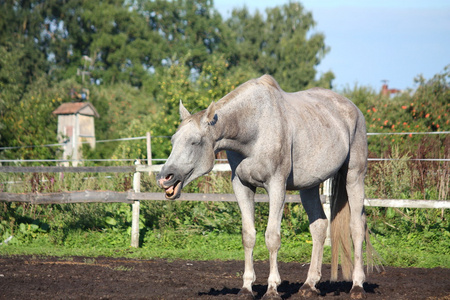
left=299, top=186, right=328, bottom=297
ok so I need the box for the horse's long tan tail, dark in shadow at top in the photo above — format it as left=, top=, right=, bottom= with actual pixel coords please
left=330, top=172, right=353, bottom=281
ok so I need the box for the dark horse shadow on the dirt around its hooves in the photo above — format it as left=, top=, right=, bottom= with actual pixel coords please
left=198, top=280, right=379, bottom=299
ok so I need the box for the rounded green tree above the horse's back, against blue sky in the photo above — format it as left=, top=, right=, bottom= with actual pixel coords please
left=227, top=3, right=334, bottom=91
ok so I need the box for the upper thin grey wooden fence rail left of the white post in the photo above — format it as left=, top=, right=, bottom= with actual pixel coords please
left=0, top=166, right=136, bottom=173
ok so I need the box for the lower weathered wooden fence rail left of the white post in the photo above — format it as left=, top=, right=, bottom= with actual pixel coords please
left=0, top=191, right=133, bottom=204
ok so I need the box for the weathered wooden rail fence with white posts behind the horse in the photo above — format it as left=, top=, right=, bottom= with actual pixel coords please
left=0, top=163, right=450, bottom=247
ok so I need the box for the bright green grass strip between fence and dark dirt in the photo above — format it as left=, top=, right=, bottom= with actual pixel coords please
left=0, top=231, right=450, bottom=268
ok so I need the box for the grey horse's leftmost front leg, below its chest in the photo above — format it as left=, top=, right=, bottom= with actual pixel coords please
left=233, top=177, right=256, bottom=299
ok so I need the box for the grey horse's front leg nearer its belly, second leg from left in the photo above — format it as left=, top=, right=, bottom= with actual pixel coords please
left=263, top=182, right=286, bottom=299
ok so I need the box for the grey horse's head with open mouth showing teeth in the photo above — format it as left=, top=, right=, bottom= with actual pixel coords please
left=156, top=101, right=216, bottom=199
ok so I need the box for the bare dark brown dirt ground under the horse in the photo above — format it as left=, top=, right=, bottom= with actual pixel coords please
left=0, top=256, right=450, bottom=300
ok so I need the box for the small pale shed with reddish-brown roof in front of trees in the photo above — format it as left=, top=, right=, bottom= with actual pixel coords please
left=53, top=102, right=100, bottom=166
